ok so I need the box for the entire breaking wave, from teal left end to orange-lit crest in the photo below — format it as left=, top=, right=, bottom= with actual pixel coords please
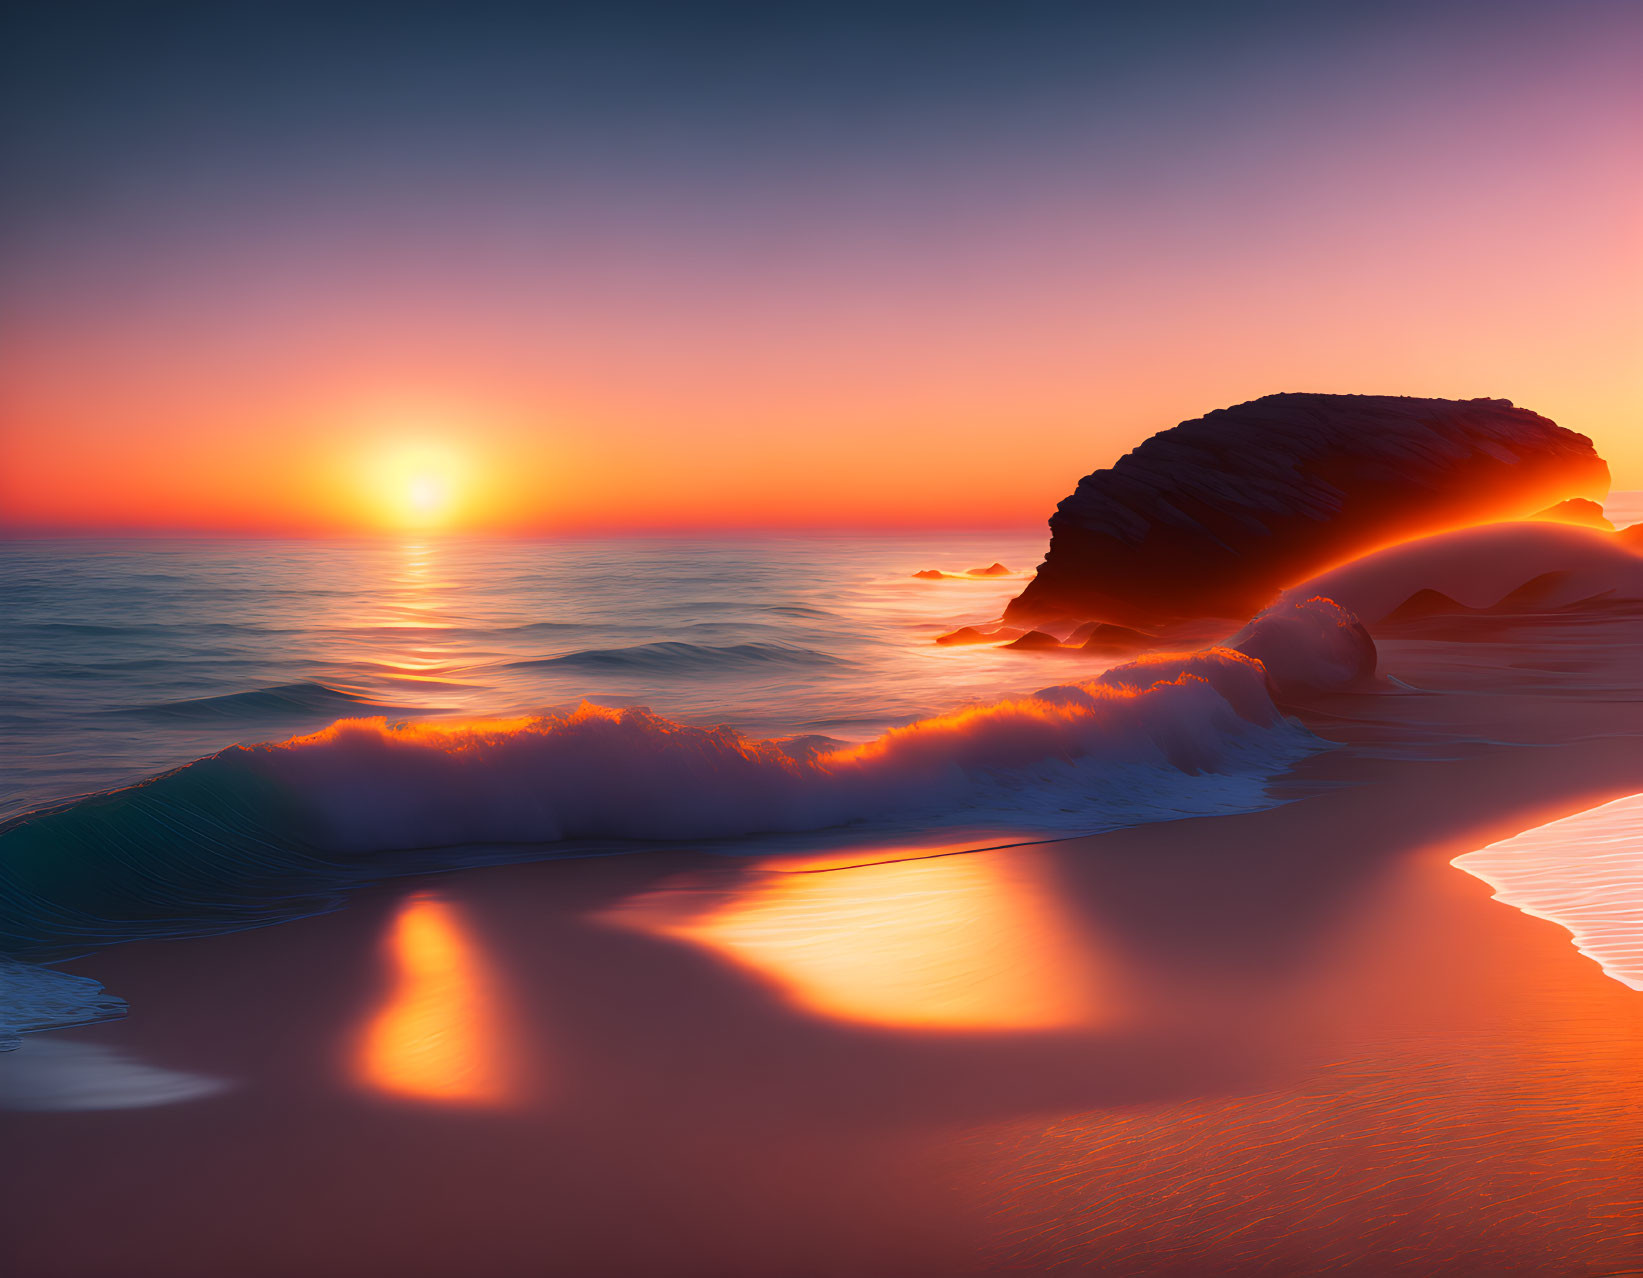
left=0, top=600, right=1374, bottom=1038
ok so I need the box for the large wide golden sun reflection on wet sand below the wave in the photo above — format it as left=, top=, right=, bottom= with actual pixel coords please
left=606, top=853, right=1109, bottom=1030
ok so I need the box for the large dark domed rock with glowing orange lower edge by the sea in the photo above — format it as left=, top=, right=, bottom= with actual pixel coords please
left=1004, top=394, right=1608, bottom=626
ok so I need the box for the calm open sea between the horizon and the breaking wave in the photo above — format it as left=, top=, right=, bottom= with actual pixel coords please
left=0, top=531, right=1045, bottom=816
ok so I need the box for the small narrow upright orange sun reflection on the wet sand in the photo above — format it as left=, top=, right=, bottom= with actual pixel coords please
left=355, top=894, right=519, bottom=1106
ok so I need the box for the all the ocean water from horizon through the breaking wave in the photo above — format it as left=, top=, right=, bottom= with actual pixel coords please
left=0, top=534, right=1332, bottom=965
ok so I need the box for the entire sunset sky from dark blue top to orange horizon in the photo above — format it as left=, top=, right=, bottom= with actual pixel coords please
left=0, top=0, right=1643, bottom=534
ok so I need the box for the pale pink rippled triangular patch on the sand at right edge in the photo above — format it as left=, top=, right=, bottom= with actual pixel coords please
left=1452, top=793, right=1643, bottom=991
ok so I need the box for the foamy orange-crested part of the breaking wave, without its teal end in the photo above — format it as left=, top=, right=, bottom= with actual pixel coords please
left=256, top=634, right=1323, bottom=853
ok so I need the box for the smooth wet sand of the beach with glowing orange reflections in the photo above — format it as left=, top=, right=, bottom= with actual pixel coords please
left=0, top=618, right=1643, bottom=1278
